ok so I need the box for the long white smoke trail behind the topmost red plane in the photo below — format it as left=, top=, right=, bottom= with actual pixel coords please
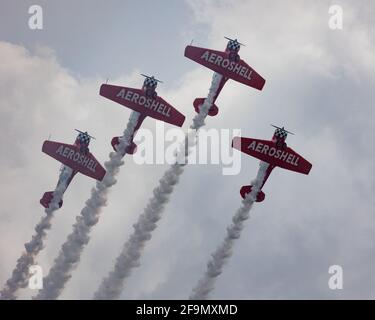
left=94, top=73, right=222, bottom=300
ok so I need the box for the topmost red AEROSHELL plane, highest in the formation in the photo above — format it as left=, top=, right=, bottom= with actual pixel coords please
left=185, top=37, right=266, bottom=116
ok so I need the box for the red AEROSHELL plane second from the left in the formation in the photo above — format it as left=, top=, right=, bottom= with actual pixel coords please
left=100, top=74, right=185, bottom=154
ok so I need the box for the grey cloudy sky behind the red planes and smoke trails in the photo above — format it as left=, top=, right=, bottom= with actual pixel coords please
left=0, top=0, right=375, bottom=299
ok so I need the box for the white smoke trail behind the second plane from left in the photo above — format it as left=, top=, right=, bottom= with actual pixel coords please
left=34, top=111, right=140, bottom=300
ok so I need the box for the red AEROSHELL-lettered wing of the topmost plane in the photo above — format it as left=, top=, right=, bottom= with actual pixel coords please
left=185, top=46, right=266, bottom=90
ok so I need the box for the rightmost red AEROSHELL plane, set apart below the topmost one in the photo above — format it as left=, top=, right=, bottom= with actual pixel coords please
left=232, top=125, right=312, bottom=202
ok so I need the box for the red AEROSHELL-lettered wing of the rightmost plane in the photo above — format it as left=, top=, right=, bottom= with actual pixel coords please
left=232, top=137, right=312, bottom=174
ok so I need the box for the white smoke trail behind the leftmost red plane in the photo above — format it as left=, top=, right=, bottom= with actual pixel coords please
left=0, top=167, right=72, bottom=300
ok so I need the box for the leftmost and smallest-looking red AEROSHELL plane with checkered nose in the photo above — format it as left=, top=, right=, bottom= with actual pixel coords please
left=40, top=129, right=106, bottom=208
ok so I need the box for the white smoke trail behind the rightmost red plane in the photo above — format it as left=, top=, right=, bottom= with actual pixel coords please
left=189, top=161, right=268, bottom=300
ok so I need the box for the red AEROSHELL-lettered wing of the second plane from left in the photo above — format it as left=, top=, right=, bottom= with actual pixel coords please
left=100, top=84, right=185, bottom=127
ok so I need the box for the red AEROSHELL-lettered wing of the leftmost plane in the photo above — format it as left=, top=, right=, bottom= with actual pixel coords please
left=42, top=140, right=106, bottom=181
